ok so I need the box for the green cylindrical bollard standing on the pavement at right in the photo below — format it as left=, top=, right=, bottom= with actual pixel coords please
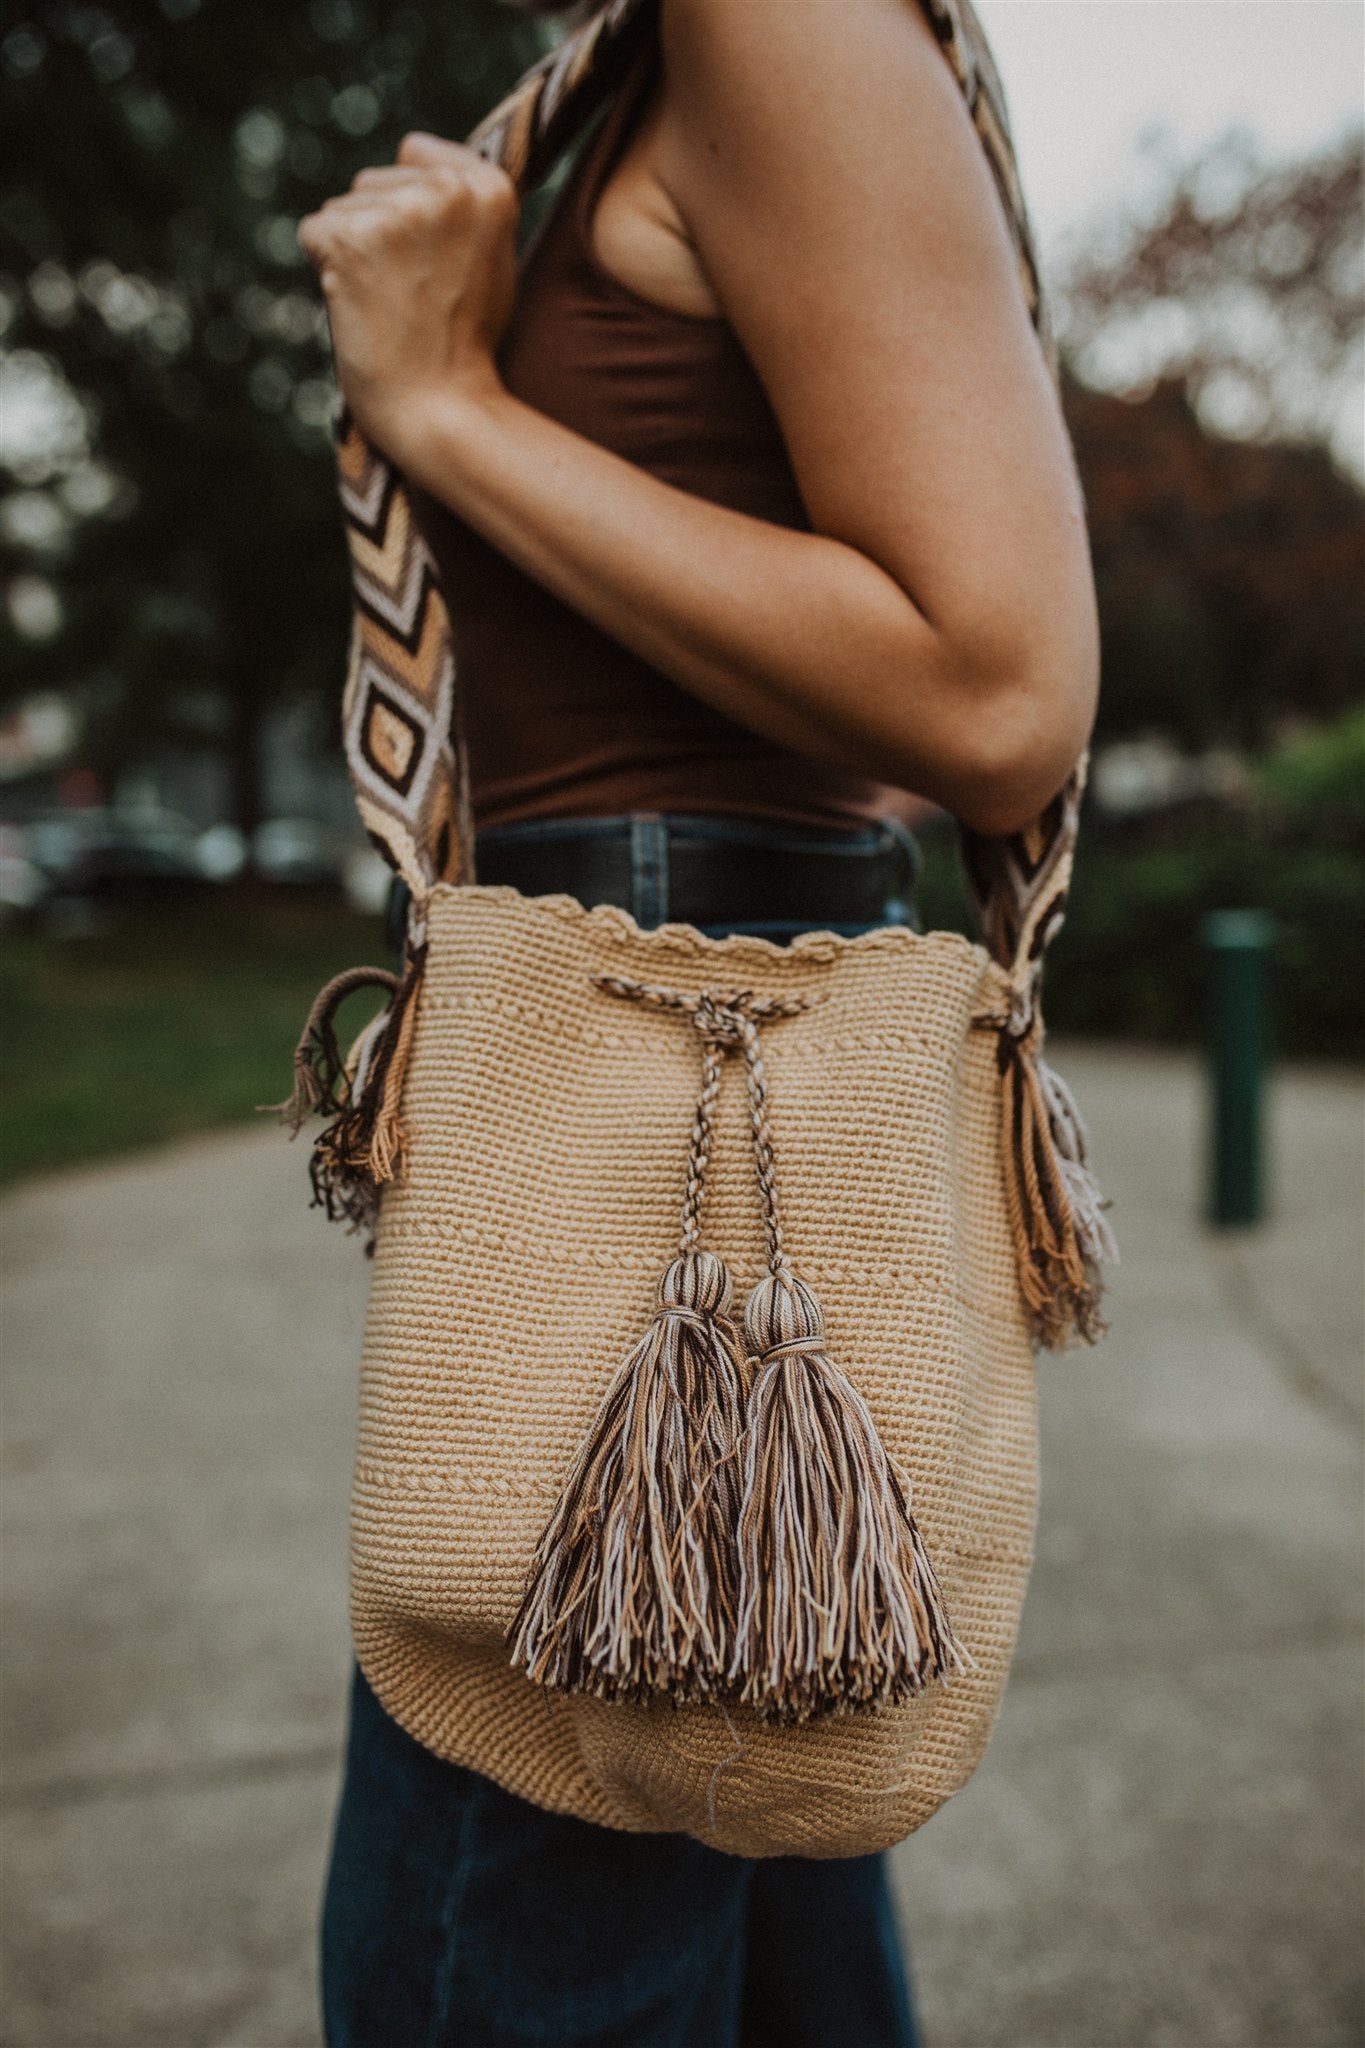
left=1203, top=909, right=1271, bottom=1231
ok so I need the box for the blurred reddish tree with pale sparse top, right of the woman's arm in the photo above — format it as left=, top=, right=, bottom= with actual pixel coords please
left=1058, top=137, right=1365, bottom=748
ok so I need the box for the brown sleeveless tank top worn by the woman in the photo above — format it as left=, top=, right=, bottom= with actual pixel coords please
left=420, top=59, right=923, bottom=827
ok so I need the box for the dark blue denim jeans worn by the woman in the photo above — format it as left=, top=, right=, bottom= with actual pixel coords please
left=331, top=817, right=917, bottom=2048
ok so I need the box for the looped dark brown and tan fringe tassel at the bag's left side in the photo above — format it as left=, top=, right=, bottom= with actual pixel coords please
left=276, top=946, right=426, bottom=1231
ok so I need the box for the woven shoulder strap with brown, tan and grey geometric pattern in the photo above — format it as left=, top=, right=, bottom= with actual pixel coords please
left=338, top=0, right=1085, bottom=995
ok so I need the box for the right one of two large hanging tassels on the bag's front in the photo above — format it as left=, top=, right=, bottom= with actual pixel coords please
left=731, top=1266, right=970, bottom=1722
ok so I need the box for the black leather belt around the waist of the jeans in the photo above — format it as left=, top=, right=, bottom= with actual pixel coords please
left=477, top=817, right=917, bottom=926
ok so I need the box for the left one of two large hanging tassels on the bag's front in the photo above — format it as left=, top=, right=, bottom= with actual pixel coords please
left=508, top=1249, right=745, bottom=1702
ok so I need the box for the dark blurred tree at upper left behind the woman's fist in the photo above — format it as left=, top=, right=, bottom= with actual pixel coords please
left=0, top=0, right=542, bottom=827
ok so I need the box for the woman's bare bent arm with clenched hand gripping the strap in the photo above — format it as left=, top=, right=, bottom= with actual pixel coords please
left=303, top=0, right=1097, bottom=831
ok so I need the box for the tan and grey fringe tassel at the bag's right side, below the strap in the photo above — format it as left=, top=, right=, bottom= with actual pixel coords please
left=990, top=1014, right=1117, bottom=1350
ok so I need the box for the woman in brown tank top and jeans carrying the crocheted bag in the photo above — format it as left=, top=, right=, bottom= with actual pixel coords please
left=301, top=0, right=1097, bottom=2048
